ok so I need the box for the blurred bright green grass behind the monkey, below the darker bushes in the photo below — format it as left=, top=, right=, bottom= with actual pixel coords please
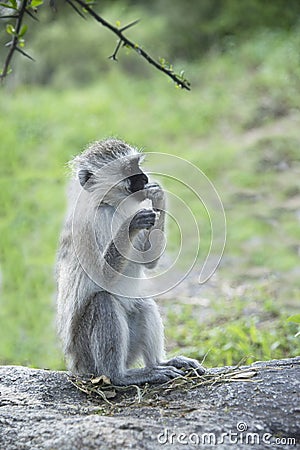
left=0, top=25, right=300, bottom=368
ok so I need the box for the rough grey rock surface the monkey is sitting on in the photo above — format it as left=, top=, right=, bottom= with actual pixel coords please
left=0, top=358, right=300, bottom=450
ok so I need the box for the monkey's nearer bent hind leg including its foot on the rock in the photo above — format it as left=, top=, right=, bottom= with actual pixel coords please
left=73, top=292, right=182, bottom=385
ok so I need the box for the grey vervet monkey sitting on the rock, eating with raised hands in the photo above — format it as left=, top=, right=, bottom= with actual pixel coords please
left=57, top=139, right=204, bottom=385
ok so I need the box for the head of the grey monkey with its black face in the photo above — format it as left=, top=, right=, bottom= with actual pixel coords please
left=71, top=139, right=148, bottom=205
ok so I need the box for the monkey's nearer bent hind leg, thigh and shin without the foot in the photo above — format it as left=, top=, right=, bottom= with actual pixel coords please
left=66, top=292, right=128, bottom=378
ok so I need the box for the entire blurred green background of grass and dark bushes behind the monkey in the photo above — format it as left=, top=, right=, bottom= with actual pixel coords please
left=0, top=1, right=300, bottom=369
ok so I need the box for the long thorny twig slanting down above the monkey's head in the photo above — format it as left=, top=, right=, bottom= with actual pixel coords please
left=68, top=0, right=191, bottom=91
